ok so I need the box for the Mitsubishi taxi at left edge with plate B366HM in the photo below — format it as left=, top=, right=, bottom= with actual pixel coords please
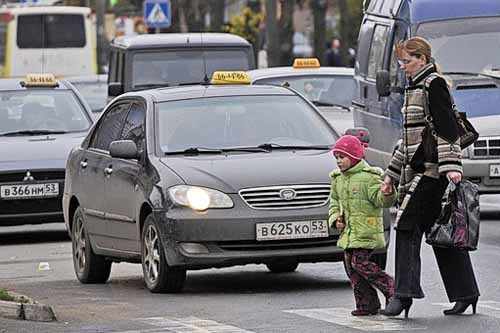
left=0, top=74, right=92, bottom=226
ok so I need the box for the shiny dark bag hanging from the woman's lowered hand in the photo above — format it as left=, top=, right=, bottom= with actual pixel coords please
left=425, top=180, right=480, bottom=251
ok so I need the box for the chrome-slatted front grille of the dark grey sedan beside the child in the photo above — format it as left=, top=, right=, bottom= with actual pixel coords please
left=239, top=184, right=330, bottom=209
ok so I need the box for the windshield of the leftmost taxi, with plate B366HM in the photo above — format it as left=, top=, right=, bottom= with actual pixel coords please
left=0, top=88, right=91, bottom=134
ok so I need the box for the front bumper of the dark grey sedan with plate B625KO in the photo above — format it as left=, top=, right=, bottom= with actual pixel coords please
left=154, top=198, right=389, bottom=269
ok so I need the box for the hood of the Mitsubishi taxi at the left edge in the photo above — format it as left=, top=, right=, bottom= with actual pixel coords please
left=0, top=133, right=85, bottom=171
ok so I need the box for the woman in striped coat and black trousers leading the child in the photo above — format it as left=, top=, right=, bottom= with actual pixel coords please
left=381, top=37, right=479, bottom=316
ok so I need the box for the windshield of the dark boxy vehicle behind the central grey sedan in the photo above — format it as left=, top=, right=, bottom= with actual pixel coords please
left=132, top=49, right=250, bottom=90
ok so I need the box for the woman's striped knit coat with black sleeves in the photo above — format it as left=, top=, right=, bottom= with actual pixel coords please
left=386, top=63, right=462, bottom=227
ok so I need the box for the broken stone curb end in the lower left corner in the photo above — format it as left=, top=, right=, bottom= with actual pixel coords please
left=0, top=293, right=56, bottom=322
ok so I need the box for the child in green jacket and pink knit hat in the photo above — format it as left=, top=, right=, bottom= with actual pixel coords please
left=328, top=135, right=396, bottom=316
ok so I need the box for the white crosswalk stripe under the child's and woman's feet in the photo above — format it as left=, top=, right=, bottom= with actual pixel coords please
left=284, top=308, right=427, bottom=331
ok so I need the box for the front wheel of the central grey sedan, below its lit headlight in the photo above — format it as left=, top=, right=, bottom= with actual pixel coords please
left=141, top=215, right=186, bottom=293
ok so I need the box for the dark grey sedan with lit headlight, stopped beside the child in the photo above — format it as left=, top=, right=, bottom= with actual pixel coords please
left=63, top=74, right=390, bottom=292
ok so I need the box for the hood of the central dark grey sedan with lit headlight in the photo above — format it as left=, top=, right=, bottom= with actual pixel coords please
left=160, top=150, right=335, bottom=193
